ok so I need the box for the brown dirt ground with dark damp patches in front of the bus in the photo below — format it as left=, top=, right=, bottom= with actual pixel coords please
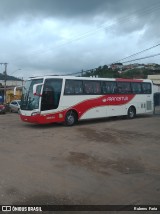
left=0, top=113, right=160, bottom=213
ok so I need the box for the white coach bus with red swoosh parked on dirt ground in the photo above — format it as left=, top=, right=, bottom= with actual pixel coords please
left=20, top=76, right=154, bottom=126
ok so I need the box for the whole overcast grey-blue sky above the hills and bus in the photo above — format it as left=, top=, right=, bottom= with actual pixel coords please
left=0, top=0, right=160, bottom=78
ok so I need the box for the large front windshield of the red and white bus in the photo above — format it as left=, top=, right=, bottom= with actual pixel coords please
left=21, top=79, right=43, bottom=110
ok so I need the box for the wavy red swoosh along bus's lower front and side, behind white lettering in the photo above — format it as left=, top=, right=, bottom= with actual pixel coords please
left=20, top=94, right=135, bottom=124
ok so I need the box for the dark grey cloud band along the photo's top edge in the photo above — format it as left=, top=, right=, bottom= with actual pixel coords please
left=0, top=0, right=158, bottom=20
